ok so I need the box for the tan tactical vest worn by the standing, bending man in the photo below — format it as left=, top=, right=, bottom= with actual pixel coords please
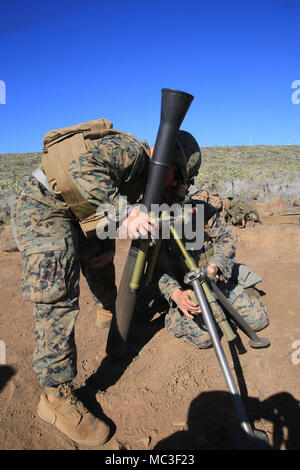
left=41, top=118, right=149, bottom=238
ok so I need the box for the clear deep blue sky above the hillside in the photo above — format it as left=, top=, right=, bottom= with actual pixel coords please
left=0, top=0, right=300, bottom=153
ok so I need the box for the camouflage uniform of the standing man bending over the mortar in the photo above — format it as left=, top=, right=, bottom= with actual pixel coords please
left=12, top=135, right=148, bottom=387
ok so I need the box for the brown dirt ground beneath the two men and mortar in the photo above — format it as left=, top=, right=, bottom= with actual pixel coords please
left=0, top=225, right=300, bottom=450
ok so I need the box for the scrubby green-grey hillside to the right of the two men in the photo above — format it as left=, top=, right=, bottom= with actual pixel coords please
left=195, top=145, right=300, bottom=201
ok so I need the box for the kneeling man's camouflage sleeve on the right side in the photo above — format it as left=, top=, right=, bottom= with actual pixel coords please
left=208, top=213, right=236, bottom=279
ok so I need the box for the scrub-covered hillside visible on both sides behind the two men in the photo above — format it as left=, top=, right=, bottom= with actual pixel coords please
left=0, top=145, right=300, bottom=220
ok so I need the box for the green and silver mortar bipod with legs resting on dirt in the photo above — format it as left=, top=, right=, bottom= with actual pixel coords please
left=130, top=212, right=270, bottom=449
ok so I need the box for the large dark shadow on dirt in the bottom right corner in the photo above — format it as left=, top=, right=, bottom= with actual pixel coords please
left=154, top=391, right=300, bottom=450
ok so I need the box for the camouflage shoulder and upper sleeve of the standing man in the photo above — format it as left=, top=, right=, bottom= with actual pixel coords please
left=69, top=134, right=149, bottom=216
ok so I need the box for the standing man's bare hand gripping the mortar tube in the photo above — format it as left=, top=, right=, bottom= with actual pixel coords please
left=120, top=206, right=158, bottom=238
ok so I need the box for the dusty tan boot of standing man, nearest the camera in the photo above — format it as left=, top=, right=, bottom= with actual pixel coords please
left=38, top=383, right=110, bottom=446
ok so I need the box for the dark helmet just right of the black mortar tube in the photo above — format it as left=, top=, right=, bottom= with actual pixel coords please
left=173, top=131, right=201, bottom=184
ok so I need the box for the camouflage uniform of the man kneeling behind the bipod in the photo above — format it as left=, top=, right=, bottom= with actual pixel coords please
left=156, top=201, right=268, bottom=348
